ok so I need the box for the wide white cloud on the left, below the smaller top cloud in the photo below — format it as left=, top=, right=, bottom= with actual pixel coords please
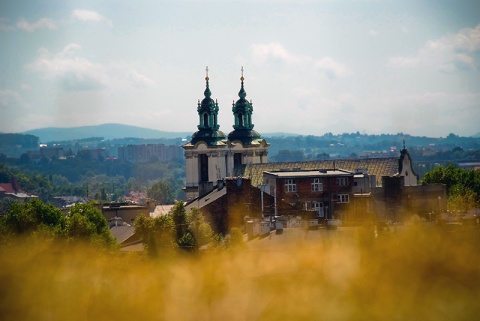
left=26, top=43, right=154, bottom=91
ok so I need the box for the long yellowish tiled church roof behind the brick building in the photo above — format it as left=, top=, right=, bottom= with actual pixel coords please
left=234, top=157, right=399, bottom=186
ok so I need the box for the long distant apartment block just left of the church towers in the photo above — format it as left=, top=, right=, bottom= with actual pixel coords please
left=118, top=144, right=183, bottom=163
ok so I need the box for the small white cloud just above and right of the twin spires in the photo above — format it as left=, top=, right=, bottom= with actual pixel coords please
left=251, top=43, right=352, bottom=79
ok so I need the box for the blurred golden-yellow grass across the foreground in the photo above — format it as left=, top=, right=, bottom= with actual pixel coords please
left=0, top=226, right=480, bottom=320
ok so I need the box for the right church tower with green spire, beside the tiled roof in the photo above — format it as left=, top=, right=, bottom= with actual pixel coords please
left=227, top=67, right=270, bottom=168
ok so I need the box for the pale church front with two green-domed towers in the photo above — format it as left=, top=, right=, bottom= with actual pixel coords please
left=182, top=68, right=270, bottom=202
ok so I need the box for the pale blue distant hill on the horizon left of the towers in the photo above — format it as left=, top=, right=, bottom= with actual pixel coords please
left=23, top=124, right=192, bottom=143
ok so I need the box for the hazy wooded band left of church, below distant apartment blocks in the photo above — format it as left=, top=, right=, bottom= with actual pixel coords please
left=0, top=157, right=185, bottom=204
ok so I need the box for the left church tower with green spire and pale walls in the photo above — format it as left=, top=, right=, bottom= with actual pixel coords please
left=182, top=67, right=228, bottom=201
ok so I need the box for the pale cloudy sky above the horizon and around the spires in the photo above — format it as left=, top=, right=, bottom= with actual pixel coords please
left=0, top=0, right=480, bottom=137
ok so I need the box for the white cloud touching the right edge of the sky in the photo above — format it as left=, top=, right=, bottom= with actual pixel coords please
left=388, top=24, right=480, bottom=72
